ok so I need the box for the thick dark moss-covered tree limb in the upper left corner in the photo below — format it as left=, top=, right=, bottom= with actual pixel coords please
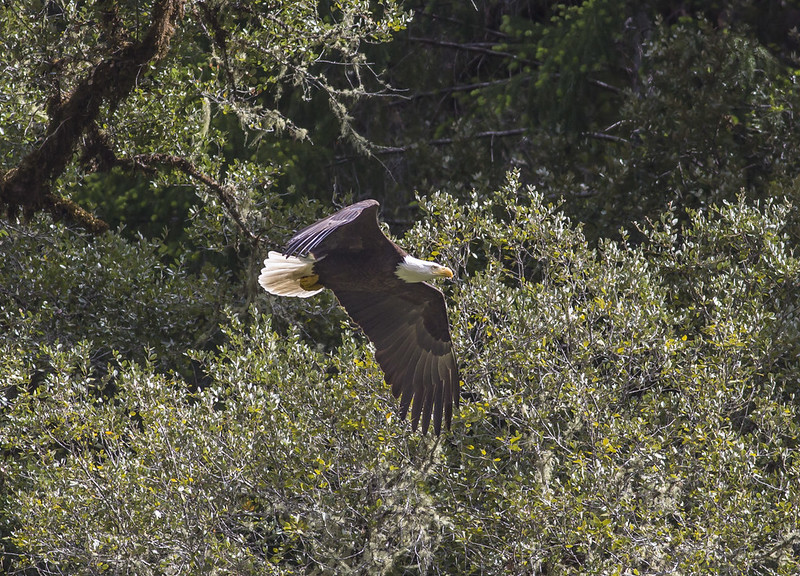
left=0, top=0, right=184, bottom=233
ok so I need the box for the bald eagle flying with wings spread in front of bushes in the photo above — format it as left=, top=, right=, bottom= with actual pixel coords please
left=258, top=200, right=459, bottom=435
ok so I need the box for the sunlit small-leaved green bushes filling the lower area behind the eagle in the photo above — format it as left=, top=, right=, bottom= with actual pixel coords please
left=0, top=178, right=800, bottom=574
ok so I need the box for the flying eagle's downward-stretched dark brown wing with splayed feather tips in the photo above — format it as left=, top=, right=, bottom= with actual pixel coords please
left=333, top=282, right=459, bottom=434
